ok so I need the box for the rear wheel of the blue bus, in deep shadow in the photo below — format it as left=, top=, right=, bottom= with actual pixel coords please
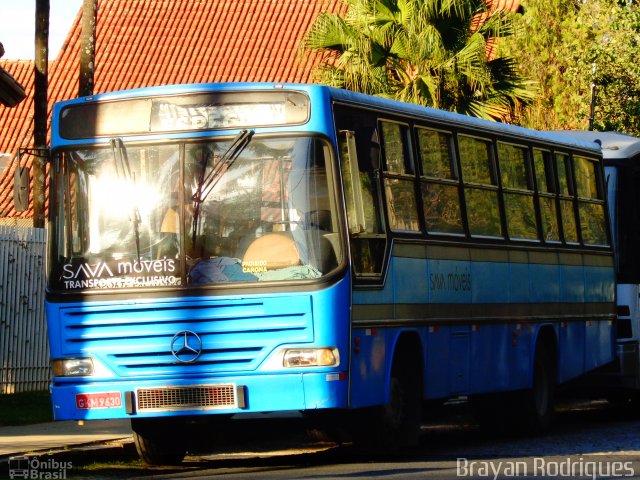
left=515, top=343, right=556, bottom=434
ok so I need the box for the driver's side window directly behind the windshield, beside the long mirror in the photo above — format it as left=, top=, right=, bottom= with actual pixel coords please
left=339, top=131, right=387, bottom=279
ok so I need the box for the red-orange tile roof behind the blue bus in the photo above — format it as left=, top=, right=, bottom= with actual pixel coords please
left=0, top=0, right=517, bottom=217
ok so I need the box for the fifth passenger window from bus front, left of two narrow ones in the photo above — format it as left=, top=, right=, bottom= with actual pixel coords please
left=533, top=148, right=560, bottom=242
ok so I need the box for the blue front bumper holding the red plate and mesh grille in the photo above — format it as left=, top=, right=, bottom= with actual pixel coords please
left=51, top=372, right=348, bottom=420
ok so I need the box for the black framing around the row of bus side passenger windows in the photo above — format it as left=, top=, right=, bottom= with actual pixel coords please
left=336, top=104, right=611, bottom=258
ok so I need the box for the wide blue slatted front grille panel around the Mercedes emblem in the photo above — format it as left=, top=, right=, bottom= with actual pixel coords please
left=60, top=295, right=314, bottom=379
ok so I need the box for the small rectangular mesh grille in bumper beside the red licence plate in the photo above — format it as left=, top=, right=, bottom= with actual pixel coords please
left=136, top=384, right=244, bottom=411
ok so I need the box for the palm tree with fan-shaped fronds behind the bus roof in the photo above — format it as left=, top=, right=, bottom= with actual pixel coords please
left=303, top=0, right=534, bottom=121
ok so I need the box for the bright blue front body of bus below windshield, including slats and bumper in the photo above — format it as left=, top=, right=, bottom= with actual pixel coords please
left=46, top=277, right=350, bottom=420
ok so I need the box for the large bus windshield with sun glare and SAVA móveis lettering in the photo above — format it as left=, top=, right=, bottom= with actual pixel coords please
left=48, top=135, right=342, bottom=291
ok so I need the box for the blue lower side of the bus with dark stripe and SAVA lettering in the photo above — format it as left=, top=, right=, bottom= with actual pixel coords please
left=351, top=248, right=615, bottom=407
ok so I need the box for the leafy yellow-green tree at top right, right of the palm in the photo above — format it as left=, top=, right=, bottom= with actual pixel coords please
left=501, top=0, right=640, bottom=134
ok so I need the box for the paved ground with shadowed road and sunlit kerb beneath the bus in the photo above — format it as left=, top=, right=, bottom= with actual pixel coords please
left=0, top=402, right=640, bottom=480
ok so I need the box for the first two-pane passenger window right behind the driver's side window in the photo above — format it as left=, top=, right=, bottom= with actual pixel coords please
left=380, top=122, right=420, bottom=231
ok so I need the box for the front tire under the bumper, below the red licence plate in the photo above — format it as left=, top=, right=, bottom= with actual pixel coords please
left=131, top=419, right=187, bottom=465
